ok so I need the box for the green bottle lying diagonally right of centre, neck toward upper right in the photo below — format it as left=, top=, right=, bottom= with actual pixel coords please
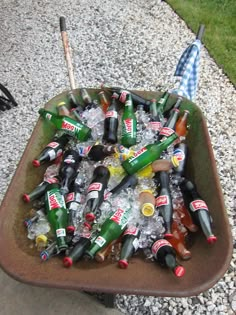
left=121, top=133, right=178, bottom=175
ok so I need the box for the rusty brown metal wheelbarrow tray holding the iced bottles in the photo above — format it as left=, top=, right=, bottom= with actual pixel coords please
left=0, top=90, right=232, bottom=297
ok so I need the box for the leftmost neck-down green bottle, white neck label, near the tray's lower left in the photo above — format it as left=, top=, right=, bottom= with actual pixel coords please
left=45, top=184, right=68, bottom=251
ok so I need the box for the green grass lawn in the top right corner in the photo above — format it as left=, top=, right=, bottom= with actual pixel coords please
left=166, top=0, right=236, bottom=85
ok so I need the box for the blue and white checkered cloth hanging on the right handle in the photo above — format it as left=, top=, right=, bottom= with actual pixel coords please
left=174, top=39, right=201, bottom=101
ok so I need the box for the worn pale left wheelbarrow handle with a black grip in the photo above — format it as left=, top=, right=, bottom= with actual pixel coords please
left=60, top=16, right=75, bottom=90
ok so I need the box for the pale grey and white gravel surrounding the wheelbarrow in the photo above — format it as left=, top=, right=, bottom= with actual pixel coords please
left=0, top=0, right=236, bottom=315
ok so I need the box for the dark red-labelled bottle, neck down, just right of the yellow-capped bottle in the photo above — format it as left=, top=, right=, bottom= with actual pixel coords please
left=156, top=171, right=173, bottom=238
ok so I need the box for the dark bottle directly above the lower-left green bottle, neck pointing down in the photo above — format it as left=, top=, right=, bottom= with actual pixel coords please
left=59, top=149, right=82, bottom=195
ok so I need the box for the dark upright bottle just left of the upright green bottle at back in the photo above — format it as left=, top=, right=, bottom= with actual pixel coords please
left=103, top=95, right=119, bottom=144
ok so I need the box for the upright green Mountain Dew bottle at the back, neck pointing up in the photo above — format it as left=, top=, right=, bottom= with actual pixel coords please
left=121, top=94, right=137, bottom=148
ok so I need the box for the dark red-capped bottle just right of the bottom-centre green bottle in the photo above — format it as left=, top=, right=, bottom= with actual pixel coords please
left=118, top=226, right=140, bottom=269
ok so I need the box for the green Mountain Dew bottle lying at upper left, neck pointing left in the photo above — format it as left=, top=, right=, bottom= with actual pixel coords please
left=39, top=108, right=91, bottom=141
